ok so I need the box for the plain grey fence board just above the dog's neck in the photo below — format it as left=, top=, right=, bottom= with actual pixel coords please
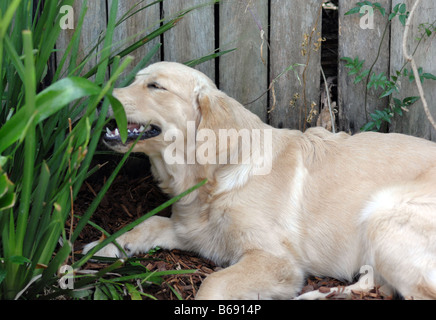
left=219, top=0, right=268, bottom=121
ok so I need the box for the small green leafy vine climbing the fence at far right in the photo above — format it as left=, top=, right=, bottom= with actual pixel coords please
left=341, top=1, right=436, bottom=131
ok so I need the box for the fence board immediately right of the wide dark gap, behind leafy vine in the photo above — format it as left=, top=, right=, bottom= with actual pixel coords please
left=338, top=0, right=391, bottom=133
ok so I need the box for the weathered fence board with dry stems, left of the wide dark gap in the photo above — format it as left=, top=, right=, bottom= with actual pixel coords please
left=270, top=0, right=322, bottom=130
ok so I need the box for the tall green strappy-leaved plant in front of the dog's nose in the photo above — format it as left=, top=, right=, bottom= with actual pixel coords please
left=0, top=0, right=218, bottom=299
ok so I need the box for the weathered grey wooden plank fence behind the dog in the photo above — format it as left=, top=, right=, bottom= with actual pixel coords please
left=58, top=0, right=436, bottom=141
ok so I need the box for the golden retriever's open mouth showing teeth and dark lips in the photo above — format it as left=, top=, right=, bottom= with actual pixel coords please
left=103, top=122, right=162, bottom=143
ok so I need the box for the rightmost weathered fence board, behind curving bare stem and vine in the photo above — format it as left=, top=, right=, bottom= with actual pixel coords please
left=390, top=0, right=436, bottom=141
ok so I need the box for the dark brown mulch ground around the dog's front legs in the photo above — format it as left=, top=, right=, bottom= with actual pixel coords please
left=74, top=157, right=391, bottom=300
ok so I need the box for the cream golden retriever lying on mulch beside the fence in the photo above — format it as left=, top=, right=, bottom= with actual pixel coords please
left=85, top=62, right=436, bottom=299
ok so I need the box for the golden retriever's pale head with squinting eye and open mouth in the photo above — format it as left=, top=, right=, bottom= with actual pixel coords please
left=104, top=62, right=218, bottom=155
